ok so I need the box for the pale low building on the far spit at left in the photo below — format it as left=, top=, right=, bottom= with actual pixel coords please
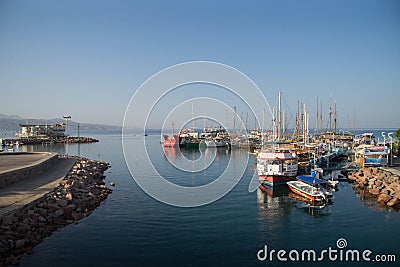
left=19, top=123, right=66, bottom=139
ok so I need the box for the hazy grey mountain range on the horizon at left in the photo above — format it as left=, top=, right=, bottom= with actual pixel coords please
left=0, top=114, right=122, bottom=131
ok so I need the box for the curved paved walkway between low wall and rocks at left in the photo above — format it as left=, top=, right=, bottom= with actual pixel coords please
left=0, top=158, right=75, bottom=218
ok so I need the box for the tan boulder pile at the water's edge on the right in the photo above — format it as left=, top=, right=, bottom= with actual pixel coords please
left=348, top=168, right=400, bottom=211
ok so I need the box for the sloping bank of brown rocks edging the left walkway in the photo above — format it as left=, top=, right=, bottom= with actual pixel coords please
left=0, top=157, right=111, bottom=266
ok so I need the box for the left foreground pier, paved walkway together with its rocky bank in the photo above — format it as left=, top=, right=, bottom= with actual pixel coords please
left=0, top=157, right=111, bottom=266
